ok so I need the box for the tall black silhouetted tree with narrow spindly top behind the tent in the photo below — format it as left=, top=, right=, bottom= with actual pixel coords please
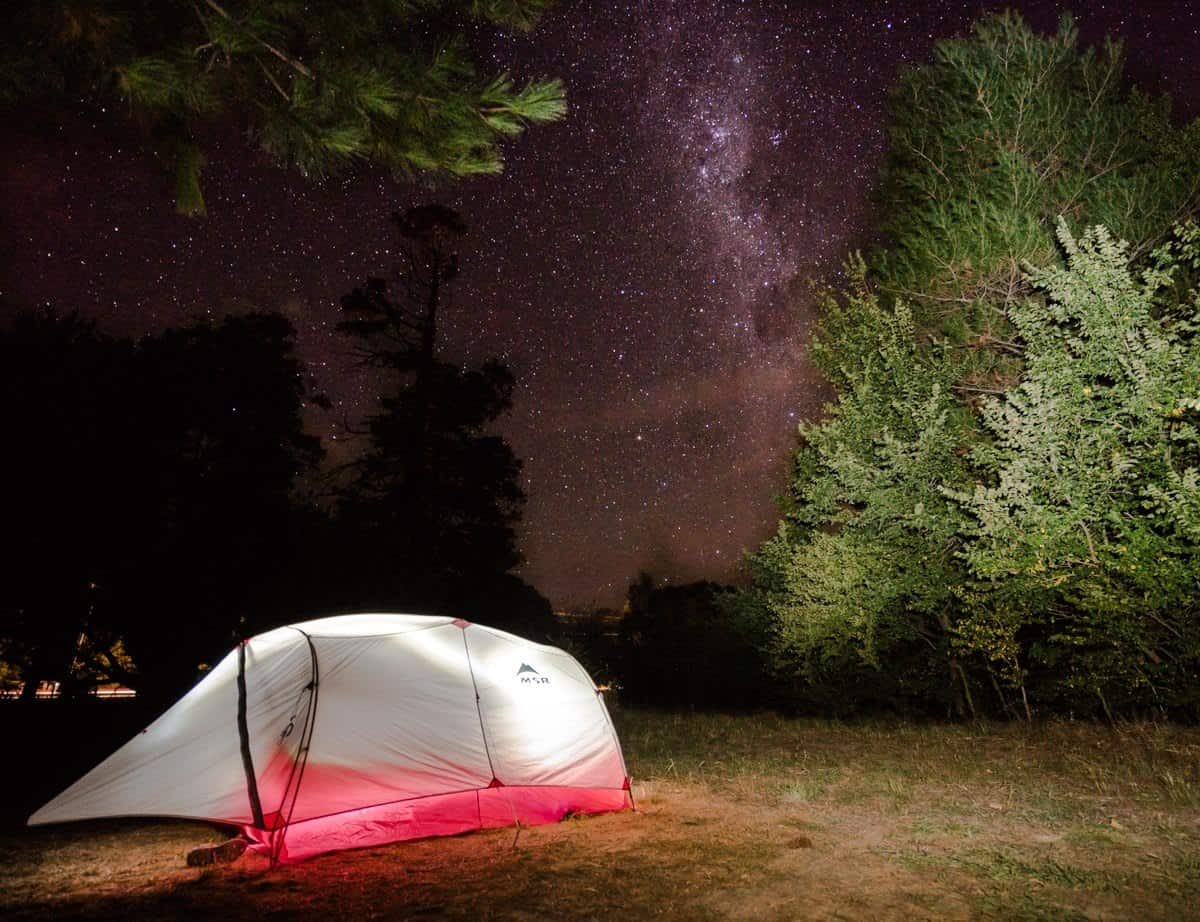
left=338, top=205, right=551, bottom=630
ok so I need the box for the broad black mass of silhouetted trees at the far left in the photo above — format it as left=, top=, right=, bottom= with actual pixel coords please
left=0, top=306, right=320, bottom=700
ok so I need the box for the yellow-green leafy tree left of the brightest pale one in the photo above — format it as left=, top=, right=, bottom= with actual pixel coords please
left=750, top=265, right=973, bottom=714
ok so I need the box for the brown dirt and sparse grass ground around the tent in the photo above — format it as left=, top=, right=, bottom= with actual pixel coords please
left=0, top=712, right=1200, bottom=922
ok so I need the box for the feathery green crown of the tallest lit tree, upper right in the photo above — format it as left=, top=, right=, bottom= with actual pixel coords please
left=872, top=12, right=1200, bottom=326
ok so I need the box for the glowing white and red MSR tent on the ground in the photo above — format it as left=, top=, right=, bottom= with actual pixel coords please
left=29, top=615, right=632, bottom=863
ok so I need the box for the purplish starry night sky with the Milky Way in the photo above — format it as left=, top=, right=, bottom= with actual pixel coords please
left=0, top=0, right=1200, bottom=605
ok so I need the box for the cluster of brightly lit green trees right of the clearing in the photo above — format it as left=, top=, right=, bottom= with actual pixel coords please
left=733, top=13, right=1200, bottom=716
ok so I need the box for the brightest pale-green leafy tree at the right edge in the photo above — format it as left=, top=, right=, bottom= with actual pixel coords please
left=956, top=222, right=1200, bottom=716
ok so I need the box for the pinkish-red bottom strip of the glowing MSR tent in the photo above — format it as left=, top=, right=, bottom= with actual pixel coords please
left=242, top=786, right=632, bottom=863
